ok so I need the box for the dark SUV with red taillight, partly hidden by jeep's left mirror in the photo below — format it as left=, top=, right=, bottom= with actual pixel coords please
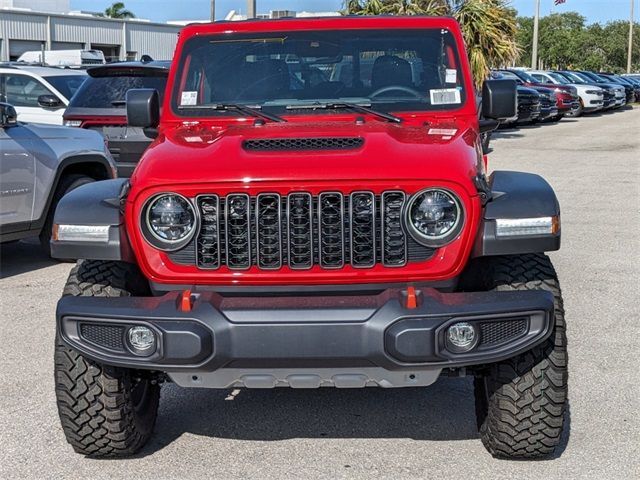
left=64, top=61, right=170, bottom=177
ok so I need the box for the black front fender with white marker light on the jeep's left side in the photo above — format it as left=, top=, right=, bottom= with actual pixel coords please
left=51, top=178, right=135, bottom=262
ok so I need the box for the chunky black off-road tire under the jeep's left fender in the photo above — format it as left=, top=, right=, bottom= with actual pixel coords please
left=54, top=260, right=160, bottom=457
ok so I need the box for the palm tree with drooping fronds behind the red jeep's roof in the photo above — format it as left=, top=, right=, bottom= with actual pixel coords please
left=346, top=0, right=519, bottom=88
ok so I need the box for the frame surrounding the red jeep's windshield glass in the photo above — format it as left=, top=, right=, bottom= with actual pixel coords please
left=163, top=26, right=476, bottom=121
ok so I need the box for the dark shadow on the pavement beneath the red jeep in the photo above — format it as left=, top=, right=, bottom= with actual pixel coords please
left=134, top=377, right=569, bottom=458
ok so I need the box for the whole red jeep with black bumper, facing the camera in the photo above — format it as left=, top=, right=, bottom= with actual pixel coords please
left=51, top=17, right=567, bottom=458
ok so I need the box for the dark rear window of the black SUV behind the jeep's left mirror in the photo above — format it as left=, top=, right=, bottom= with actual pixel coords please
left=69, top=75, right=167, bottom=108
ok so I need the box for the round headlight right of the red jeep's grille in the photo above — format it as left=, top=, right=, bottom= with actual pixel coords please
left=405, top=188, right=463, bottom=247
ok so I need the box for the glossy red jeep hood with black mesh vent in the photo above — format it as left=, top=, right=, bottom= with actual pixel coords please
left=132, top=117, right=482, bottom=193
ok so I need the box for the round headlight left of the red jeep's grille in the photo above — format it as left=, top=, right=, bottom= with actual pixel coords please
left=142, top=193, right=196, bottom=250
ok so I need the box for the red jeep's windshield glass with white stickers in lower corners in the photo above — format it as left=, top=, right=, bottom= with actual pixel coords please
left=172, top=29, right=466, bottom=116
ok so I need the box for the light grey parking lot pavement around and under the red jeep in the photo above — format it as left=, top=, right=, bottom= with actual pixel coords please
left=0, top=108, right=640, bottom=480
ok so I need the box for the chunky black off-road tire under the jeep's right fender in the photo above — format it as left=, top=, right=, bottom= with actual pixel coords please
left=462, top=254, right=568, bottom=459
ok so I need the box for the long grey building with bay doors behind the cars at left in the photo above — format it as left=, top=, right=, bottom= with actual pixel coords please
left=0, top=7, right=181, bottom=61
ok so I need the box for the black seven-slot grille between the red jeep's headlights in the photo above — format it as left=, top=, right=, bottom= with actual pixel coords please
left=169, top=190, right=435, bottom=270
